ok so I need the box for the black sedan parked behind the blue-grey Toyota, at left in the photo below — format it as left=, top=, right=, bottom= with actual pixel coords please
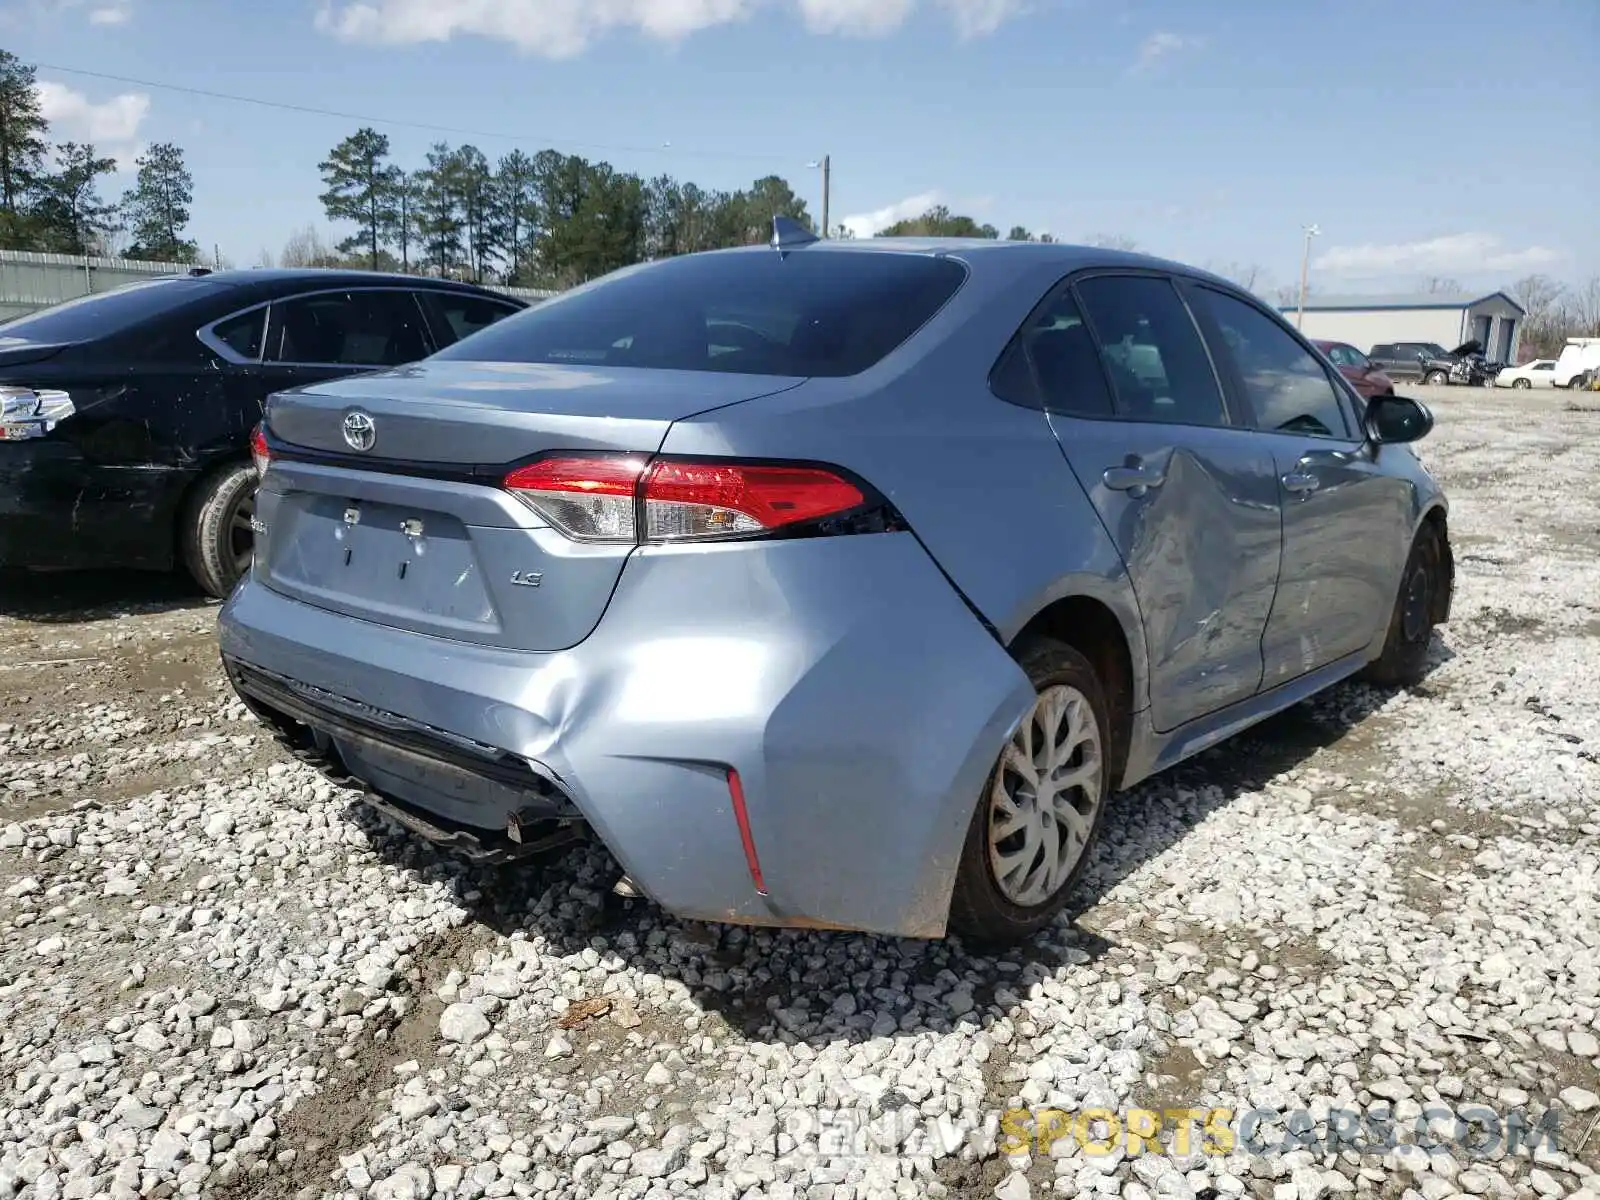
left=0, top=269, right=525, bottom=597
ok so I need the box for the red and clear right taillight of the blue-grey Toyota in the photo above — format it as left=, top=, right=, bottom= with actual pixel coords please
left=506, top=458, right=867, bottom=542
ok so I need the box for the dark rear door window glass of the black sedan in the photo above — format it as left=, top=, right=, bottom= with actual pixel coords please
left=266, top=288, right=432, bottom=366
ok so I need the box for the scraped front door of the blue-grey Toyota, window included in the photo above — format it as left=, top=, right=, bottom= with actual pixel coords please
left=1186, top=283, right=1411, bottom=688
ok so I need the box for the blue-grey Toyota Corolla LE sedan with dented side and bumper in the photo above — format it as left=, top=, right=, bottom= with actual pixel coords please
left=221, top=219, right=1454, bottom=941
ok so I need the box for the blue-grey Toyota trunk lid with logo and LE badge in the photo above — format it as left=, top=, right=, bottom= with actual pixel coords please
left=265, top=362, right=803, bottom=651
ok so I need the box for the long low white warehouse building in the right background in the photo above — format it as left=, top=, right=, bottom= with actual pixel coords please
left=1280, top=291, right=1528, bottom=363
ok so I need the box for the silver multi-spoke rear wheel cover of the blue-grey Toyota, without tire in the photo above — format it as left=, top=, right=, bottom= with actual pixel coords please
left=987, top=685, right=1106, bottom=907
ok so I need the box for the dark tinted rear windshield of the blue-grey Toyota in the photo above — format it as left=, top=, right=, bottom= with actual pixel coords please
left=435, top=250, right=966, bottom=376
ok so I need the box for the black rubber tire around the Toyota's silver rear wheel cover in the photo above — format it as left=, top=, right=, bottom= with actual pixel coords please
left=949, top=638, right=1112, bottom=946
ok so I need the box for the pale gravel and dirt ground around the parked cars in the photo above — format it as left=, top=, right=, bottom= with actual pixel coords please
left=0, top=390, right=1600, bottom=1200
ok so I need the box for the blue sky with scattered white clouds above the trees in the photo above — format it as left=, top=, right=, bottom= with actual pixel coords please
left=0, top=0, right=1600, bottom=291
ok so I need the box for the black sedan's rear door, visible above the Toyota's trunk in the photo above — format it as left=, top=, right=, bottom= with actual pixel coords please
left=253, top=288, right=435, bottom=403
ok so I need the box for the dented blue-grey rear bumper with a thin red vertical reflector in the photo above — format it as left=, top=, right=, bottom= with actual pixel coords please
left=222, top=533, right=1032, bottom=936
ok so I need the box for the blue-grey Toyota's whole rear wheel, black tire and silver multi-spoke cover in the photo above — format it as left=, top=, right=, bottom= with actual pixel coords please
left=950, top=638, right=1110, bottom=942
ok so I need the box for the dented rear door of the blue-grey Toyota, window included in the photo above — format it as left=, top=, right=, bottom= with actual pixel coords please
left=997, top=274, right=1280, bottom=733
